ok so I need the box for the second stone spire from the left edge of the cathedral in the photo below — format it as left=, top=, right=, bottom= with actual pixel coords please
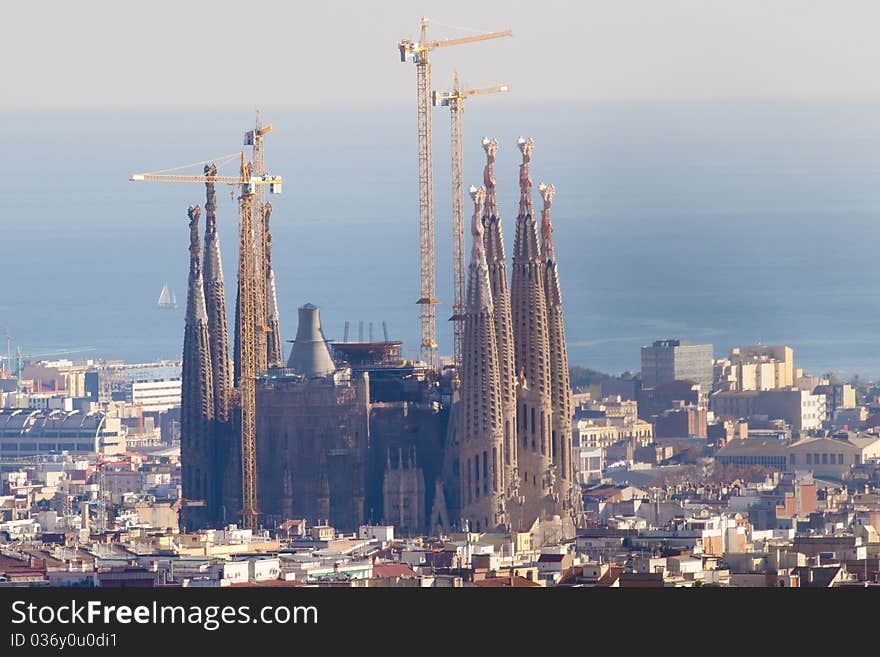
left=204, top=164, right=232, bottom=422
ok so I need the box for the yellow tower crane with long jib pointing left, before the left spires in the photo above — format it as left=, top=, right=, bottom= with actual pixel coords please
left=131, top=151, right=282, bottom=530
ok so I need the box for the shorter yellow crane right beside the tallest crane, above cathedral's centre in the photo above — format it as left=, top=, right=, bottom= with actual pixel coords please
left=431, top=71, right=510, bottom=371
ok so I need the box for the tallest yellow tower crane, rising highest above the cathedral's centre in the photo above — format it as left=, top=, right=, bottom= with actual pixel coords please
left=398, top=18, right=513, bottom=369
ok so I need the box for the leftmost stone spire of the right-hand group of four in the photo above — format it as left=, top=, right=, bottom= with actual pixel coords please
left=460, top=187, right=506, bottom=531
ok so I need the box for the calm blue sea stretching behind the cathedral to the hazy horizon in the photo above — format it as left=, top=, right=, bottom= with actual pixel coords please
left=0, top=99, right=880, bottom=377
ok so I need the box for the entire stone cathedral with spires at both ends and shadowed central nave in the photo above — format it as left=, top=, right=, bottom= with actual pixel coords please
left=181, top=139, right=582, bottom=544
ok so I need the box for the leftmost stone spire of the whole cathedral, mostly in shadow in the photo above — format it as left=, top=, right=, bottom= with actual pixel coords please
left=180, top=206, right=219, bottom=529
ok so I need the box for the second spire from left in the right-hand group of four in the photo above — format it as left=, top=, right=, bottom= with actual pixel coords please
left=482, top=137, right=518, bottom=484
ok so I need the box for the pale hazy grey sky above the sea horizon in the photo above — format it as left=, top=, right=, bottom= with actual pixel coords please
left=0, top=0, right=880, bottom=108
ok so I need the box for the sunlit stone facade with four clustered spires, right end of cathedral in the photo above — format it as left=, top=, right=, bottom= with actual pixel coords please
left=445, top=139, right=582, bottom=534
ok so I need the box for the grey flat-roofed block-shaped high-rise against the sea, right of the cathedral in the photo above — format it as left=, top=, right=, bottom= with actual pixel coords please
left=642, top=338, right=714, bottom=392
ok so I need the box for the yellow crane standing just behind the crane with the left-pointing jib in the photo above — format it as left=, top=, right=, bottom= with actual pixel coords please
left=244, top=110, right=280, bottom=372
